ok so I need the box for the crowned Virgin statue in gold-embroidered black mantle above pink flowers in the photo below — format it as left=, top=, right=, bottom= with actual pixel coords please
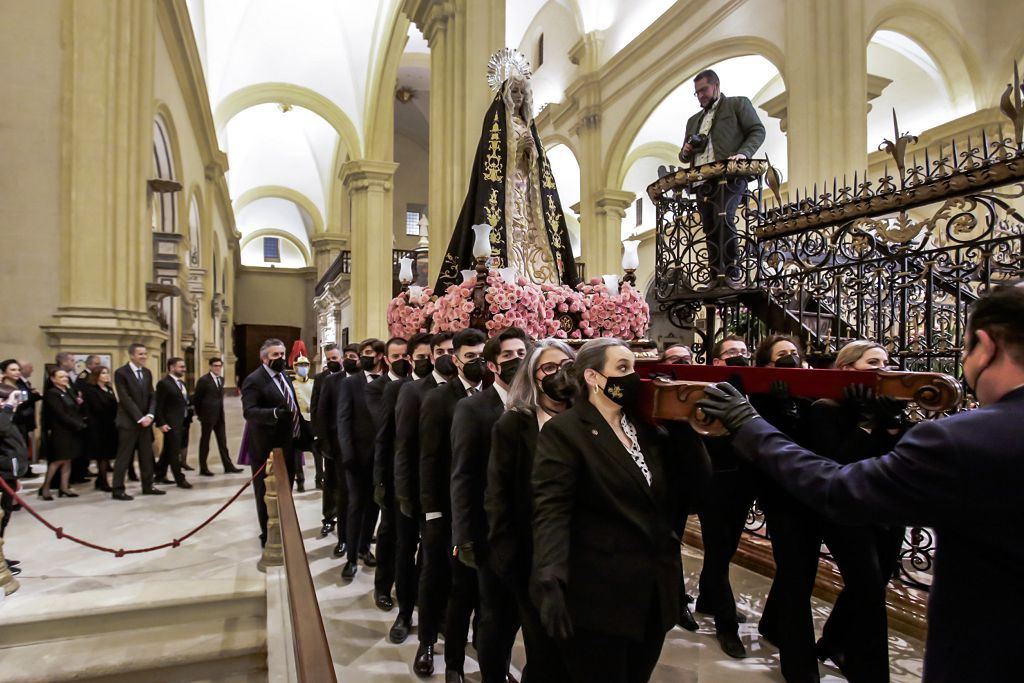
left=434, top=48, right=577, bottom=292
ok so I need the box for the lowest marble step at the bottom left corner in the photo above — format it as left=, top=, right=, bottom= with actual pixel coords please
left=0, top=615, right=266, bottom=683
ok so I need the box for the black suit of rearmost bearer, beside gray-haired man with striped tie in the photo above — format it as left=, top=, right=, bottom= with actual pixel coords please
left=309, top=372, right=348, bottom=542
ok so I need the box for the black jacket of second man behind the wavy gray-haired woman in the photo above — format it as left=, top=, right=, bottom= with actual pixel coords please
left=420, top=378, right=466, bottom=517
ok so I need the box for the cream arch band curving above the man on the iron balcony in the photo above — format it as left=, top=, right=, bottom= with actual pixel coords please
left=604, top=36, right=785, bottom=187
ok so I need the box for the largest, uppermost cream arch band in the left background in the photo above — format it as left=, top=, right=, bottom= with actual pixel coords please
left=213, top=83, right=362, bottom=159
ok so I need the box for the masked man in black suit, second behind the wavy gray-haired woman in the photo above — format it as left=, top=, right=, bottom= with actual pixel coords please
left=413, top=328, right=486, bottom=681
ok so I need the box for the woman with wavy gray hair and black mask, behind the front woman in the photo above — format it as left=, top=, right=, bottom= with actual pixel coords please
left=483, top=339, right=575, bottom=681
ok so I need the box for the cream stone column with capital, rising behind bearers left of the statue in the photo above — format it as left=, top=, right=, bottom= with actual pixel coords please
left=341, top=160, right=398, bottom=339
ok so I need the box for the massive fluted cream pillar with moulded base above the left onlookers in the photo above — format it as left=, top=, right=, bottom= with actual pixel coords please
left=43, top=0, right=166, bottom=358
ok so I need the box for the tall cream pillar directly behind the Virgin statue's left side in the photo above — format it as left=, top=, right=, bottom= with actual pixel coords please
left=402, top=0, right=505, bottom=284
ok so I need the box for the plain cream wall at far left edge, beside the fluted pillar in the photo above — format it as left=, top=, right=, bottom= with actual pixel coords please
left=0, top=0, right=64, bottom=370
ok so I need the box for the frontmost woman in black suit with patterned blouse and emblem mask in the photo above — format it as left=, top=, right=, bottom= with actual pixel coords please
left=530, top=338, right=702, bottom=683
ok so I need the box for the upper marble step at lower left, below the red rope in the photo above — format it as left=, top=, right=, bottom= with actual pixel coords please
left=0, top=579, right=266, bottom=656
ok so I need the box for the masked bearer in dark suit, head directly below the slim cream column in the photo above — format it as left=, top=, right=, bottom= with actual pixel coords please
left=337, top=339, right=385, bottom=581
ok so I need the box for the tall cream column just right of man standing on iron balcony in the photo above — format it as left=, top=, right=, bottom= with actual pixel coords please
left=784, top=0, right=867, bottom=192
